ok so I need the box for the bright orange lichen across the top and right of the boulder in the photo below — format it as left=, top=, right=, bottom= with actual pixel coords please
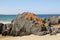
left=23, top=12, right=44, bottom=27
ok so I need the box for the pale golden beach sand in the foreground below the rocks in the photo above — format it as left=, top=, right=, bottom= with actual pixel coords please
left=0, top=34, right=60, bottom=40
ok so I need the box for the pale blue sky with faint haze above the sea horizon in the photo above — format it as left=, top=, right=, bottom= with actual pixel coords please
left=0, top=0, right=60, bottom=14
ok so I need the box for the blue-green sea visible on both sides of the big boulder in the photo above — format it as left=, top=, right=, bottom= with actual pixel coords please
left=0, top=14, right=60, bottom=21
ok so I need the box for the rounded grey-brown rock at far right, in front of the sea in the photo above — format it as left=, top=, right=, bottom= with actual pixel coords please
left=45, top=16, right=60, bottom=25
